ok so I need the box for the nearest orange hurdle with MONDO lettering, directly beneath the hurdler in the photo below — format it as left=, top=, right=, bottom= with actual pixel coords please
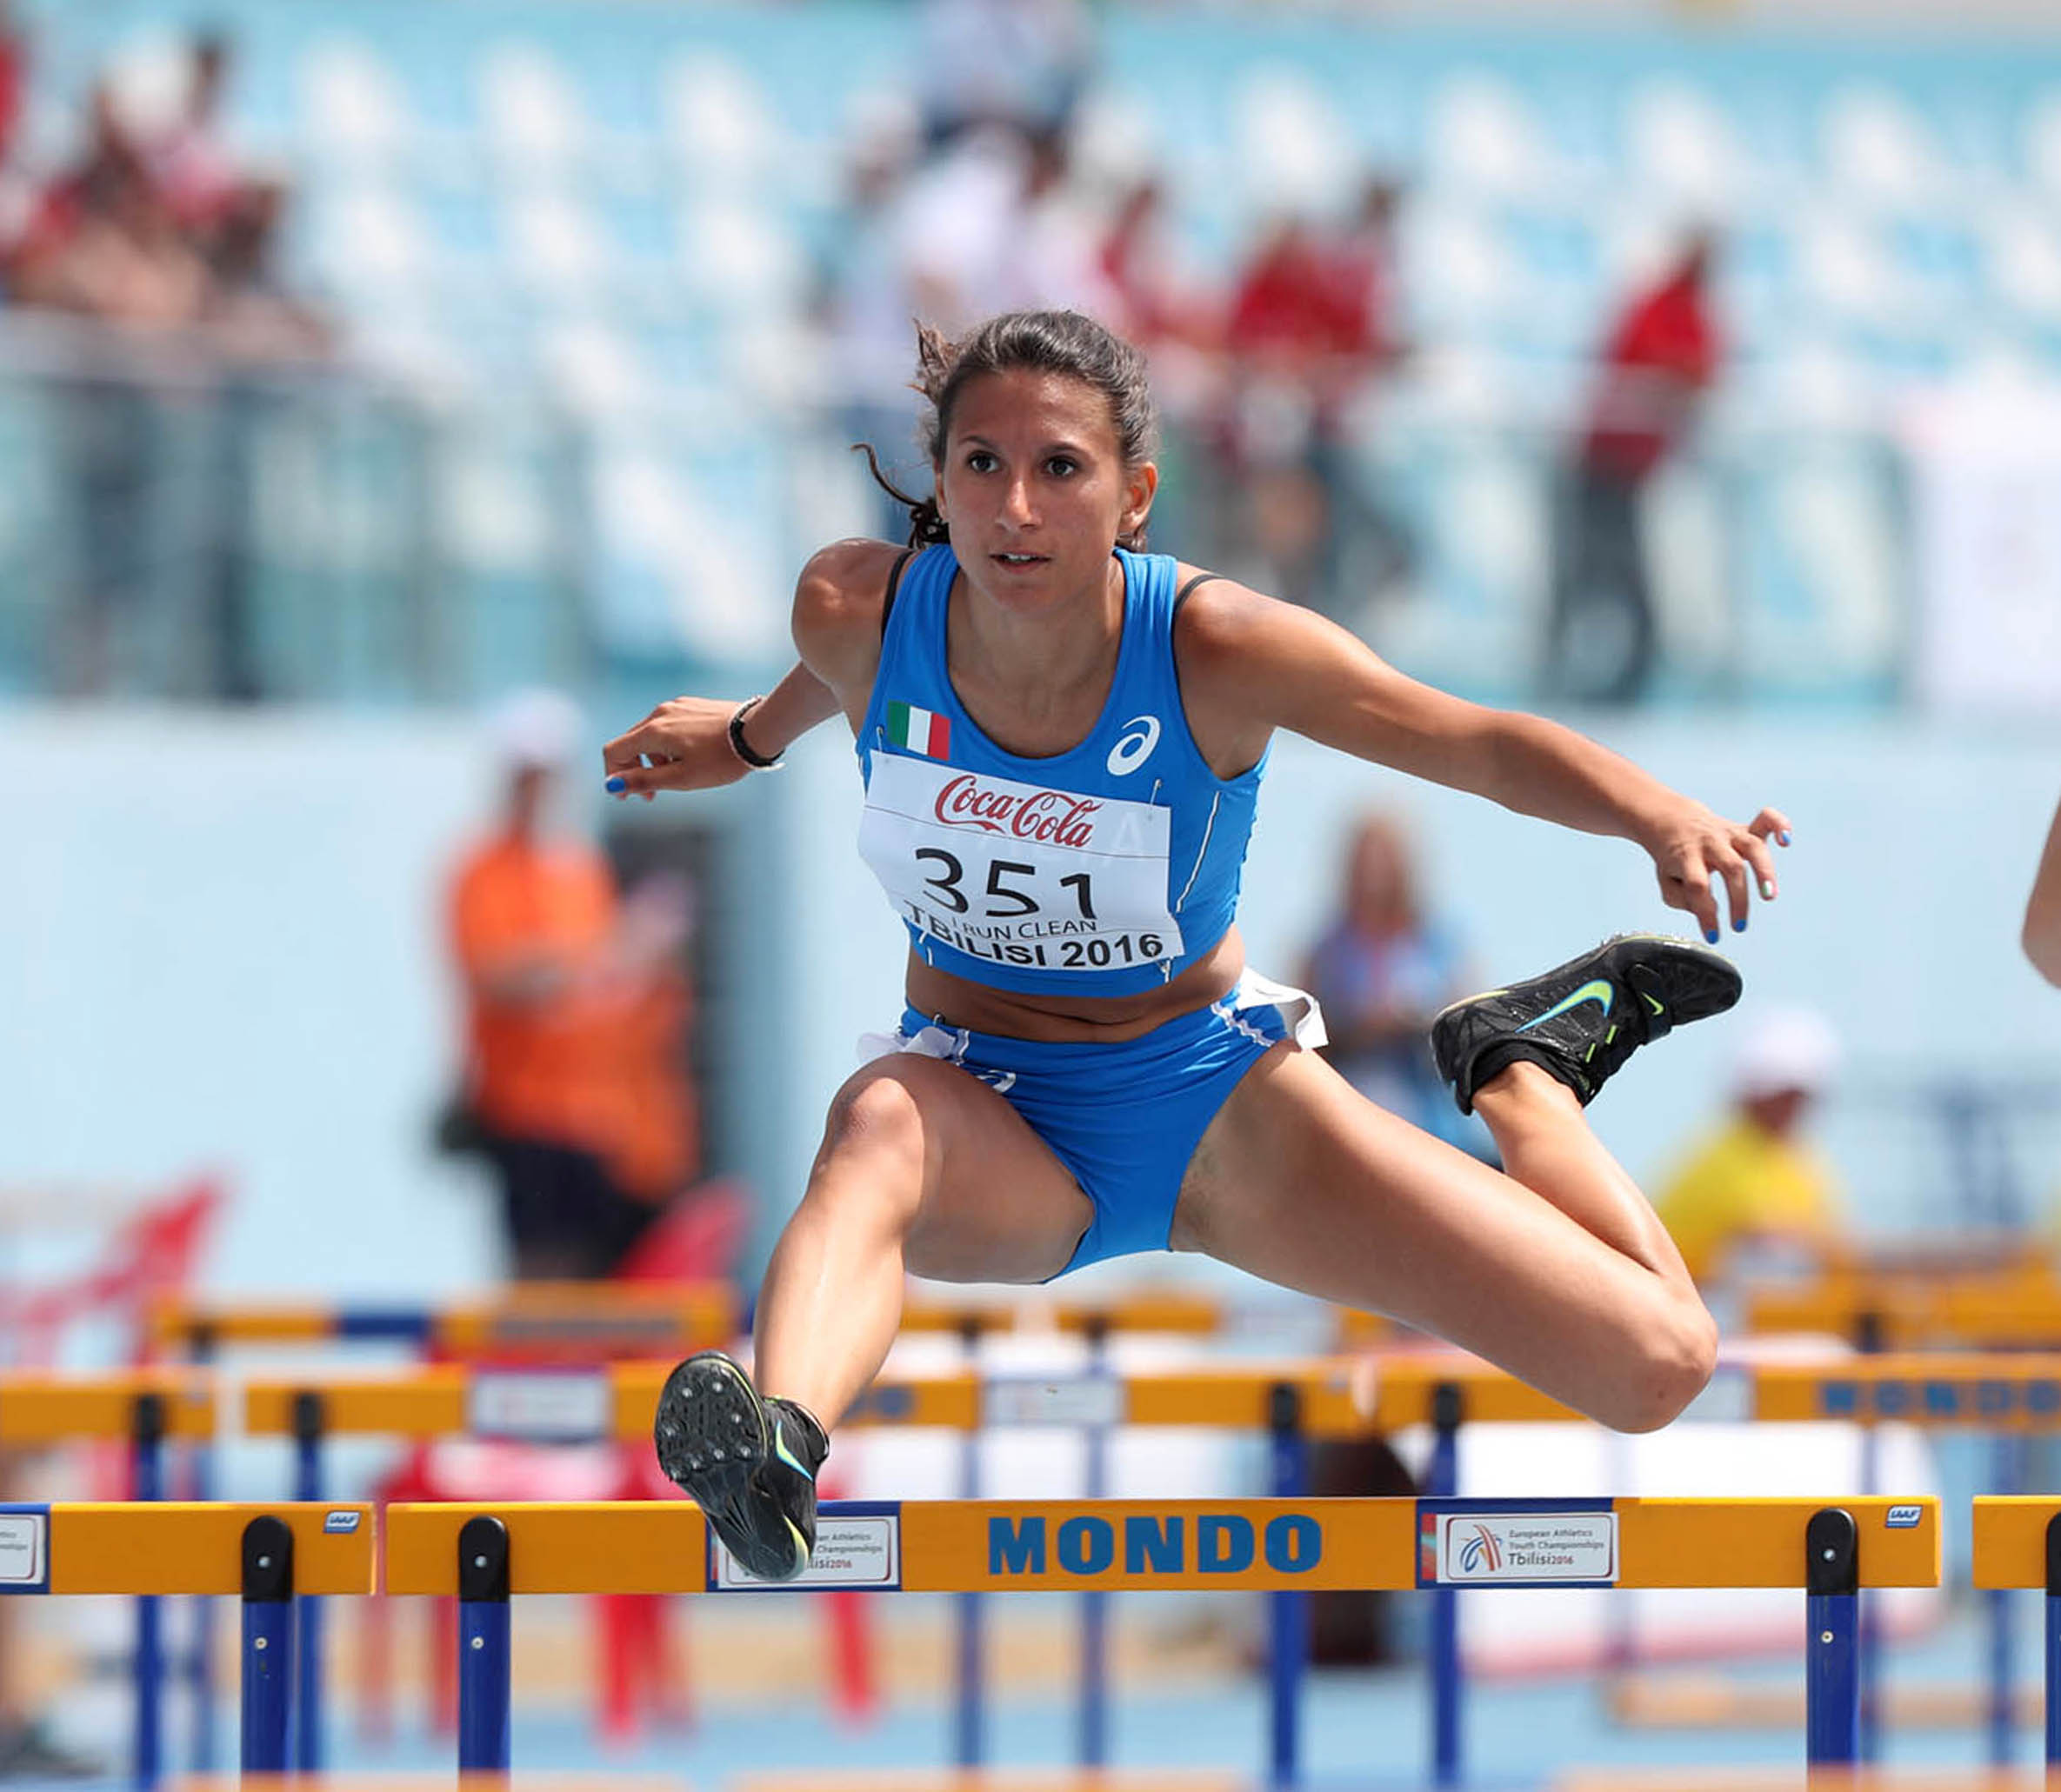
left=385, top=1500, right=1939, bottom=1784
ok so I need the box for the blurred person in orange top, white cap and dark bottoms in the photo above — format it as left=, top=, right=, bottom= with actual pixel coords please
left=445, top=692, right=695, bottom=1279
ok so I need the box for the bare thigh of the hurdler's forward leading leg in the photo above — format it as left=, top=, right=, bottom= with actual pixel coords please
left=818, top=1053, right=1094, bottom=1281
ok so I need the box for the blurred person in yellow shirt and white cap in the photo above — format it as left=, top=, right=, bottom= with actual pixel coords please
left=1655, top=1009, right=1840, bottom=1283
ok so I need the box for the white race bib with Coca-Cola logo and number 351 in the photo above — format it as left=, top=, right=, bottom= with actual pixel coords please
left=859, top=752, right=1181, bottom=970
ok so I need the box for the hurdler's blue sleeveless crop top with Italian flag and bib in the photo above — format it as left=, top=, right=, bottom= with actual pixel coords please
left=857, top=546, right=1265, bottom=995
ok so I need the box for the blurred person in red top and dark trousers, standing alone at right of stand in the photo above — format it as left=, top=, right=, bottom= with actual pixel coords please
left=1546, top=230, right=1721, bottom=703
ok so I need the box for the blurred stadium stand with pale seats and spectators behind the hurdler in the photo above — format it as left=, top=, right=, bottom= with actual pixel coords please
left=0, top=0, right=2061, bottom=710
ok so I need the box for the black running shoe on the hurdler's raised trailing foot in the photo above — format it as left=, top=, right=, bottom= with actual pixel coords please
left=1431, top=933, right=1739, bottom=1115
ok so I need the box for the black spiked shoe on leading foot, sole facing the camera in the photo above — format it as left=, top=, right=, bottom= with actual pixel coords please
left=651, top=1351, right=830, bottom=1580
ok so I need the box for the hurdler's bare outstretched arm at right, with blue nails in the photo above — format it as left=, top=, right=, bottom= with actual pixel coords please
left=1177, top=581, right=1789, bottom=937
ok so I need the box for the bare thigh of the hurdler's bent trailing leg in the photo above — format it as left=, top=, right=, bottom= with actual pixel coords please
left=1173, top=1046, right=1651, bottom=1389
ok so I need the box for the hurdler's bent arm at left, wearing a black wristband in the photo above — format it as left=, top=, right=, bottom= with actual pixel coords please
left=602, top=542, right=897, bottom=799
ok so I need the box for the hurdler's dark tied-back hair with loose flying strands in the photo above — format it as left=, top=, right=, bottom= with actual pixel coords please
left=857, top=311, right=1158, bottom=552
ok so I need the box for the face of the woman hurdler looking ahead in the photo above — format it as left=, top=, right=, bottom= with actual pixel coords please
left=937, top=369, right=1158, bottom=603
